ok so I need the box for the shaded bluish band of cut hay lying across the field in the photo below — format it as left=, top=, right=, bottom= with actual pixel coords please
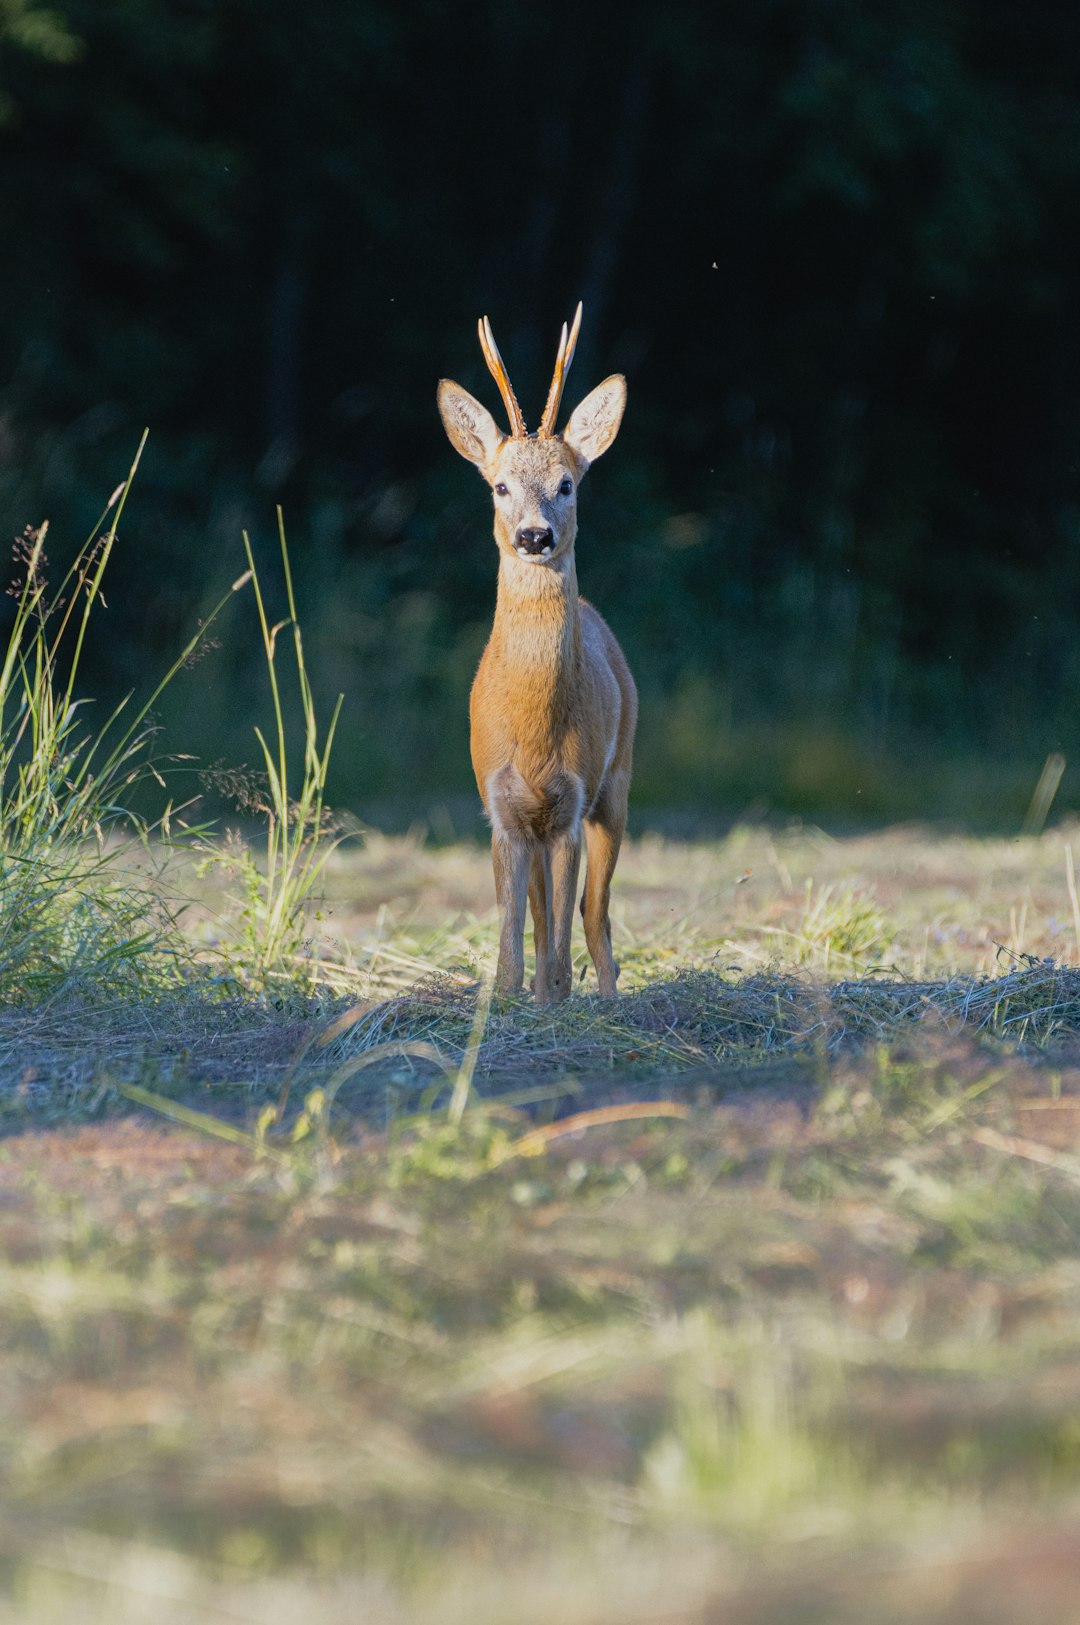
left=0, top=960, right=1080, bottom=1121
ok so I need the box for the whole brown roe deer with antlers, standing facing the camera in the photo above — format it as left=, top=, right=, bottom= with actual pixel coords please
left=438, top=306, right=638, bottom=1004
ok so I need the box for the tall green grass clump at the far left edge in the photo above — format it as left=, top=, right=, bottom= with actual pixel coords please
left=0, top=436, right=222, bottom=999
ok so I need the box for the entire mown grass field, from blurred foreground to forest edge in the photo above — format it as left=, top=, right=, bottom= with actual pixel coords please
left=0, top=827, right=1080, bottom=1625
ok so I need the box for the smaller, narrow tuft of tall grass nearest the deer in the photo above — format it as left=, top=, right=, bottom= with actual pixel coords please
left=203, top=509, right=351, bottom=991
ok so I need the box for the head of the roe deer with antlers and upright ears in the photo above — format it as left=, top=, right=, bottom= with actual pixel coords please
left=438, top=304, right=627, bottom=566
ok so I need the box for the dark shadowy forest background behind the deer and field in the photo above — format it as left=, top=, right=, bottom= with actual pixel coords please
left=0, top=0, right=1080, bottom=832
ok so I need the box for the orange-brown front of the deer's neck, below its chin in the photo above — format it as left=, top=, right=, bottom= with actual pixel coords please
left=492, top=553, right=583, bottom=756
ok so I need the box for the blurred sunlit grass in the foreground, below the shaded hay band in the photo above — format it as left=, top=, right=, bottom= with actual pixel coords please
left=0, top=1014, right=1080, bottom=1622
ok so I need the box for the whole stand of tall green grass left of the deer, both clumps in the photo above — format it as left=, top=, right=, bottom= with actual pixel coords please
left=0, top=451, right=346, bottom=1003
